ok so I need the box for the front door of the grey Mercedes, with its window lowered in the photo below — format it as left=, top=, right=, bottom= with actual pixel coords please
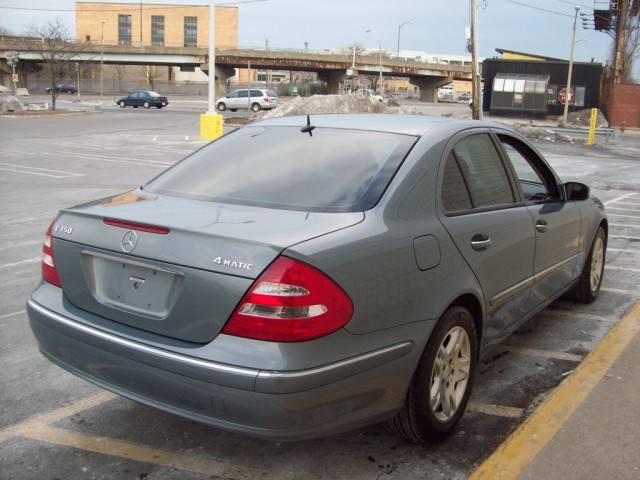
left=497, top=132, right=581, bottom=306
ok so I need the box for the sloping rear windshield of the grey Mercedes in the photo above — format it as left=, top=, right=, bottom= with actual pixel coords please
left=144, top=126, right=416, bottom=212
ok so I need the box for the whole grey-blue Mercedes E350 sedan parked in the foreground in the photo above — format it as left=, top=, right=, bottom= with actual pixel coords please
left=28, top=115, right=608, bottom=442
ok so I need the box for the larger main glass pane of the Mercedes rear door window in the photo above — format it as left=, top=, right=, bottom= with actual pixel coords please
left=453, top=134, right=515, bottom=208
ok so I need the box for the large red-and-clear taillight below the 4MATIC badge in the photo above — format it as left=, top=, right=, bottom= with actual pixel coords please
left=223, top=257, right=353, bottom=342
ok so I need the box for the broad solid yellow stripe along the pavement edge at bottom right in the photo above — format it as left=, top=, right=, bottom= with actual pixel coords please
left=469, top=303, right=640, bottom=480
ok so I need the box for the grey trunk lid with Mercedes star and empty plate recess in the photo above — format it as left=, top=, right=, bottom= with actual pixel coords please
left=53, top=191, right=364, bottom=343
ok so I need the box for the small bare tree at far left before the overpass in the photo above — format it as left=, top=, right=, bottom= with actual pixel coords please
left=27, top=19, right=78, bottom=110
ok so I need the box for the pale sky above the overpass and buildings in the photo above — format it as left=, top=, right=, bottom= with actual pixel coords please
left=0, top=0, right=611, bottom=62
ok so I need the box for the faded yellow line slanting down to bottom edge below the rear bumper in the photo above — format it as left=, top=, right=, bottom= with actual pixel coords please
left=22, top=426, right=270, bottom=480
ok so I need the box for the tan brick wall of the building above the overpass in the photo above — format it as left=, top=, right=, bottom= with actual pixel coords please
left=76, top=2, right=238, bottom=47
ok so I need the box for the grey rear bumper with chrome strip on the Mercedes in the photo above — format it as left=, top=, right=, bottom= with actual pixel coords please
left=27, top=299, right=419, bottom=440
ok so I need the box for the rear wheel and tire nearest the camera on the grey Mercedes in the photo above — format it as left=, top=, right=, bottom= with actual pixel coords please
left=387, top=306, right=478, bottom=443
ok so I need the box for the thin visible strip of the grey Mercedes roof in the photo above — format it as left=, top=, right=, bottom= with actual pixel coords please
left=253, top=113, right=504, bottom=136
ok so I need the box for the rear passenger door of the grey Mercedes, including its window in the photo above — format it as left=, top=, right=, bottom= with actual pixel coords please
left=439, top=129, right=535, bottom=340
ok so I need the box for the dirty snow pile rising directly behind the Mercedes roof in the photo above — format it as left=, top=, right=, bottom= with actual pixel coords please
left=257, top=95, right=405, bottom=120
